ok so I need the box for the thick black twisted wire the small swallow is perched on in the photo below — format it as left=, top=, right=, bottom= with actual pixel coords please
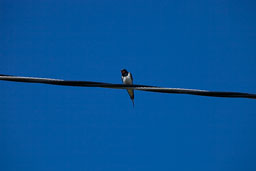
left=0, top=74, right=256, bottom=99
